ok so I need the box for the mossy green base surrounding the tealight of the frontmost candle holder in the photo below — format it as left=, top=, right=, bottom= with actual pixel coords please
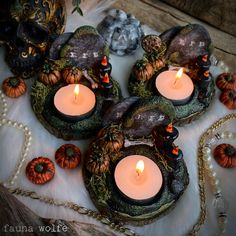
left=83, top=145, right=189, bottom=225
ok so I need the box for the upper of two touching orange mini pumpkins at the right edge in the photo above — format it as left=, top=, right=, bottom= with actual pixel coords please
left=216, top=73, right=236, bottom=90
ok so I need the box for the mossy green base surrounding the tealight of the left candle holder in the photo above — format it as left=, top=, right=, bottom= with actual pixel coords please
left=31, top=80, right=121, bottom=140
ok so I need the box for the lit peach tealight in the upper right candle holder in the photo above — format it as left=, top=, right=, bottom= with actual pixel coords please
left=156, top=68, right=194, bottom=105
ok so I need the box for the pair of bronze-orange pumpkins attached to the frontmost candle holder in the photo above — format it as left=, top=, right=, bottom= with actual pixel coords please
left=85, top=126, right=125, bottom=174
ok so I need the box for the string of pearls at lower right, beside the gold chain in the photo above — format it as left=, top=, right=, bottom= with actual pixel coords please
left=202, top=131, right=236, bottom=235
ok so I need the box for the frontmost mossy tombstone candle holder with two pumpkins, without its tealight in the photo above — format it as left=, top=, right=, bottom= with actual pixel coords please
left=83, top=99, right=189, bottom=225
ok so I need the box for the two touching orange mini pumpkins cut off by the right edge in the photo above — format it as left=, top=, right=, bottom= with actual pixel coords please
left=216, top=72, right=236, bottom=110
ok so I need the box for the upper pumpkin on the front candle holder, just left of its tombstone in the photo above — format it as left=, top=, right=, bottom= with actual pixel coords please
left=97, top=127, right=124, bottom=153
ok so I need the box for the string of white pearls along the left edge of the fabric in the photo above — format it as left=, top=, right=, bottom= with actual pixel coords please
left=0, top=90, right=32, bottom=187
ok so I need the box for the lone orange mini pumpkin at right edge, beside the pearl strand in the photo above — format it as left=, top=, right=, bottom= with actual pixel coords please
left=213, top=143, right=236, bottom=168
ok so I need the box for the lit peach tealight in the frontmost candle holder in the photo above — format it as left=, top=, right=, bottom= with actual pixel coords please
left=114, top=155, right=163, bottom=203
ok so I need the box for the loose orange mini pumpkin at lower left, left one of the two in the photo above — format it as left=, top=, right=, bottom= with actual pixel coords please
left=26, top=157, right=55, bottom=184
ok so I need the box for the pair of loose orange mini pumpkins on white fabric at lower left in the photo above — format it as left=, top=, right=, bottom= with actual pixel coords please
left=26, top=144, right=81, bottom=185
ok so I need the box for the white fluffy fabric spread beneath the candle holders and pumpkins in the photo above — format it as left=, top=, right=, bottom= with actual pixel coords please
left=0, top=2, right=236, bottom=236
